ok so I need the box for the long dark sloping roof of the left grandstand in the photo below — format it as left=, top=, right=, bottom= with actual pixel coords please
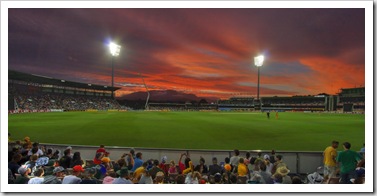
left=8, top=70, right=120, bottom=91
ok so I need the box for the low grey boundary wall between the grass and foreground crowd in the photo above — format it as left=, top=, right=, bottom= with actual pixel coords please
left=27, top=144, right=323, bottom=174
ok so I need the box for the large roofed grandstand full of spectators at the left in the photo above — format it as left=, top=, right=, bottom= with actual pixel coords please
left=8, top=70, right=121, bottom=113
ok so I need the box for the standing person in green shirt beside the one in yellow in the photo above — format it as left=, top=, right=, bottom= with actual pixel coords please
left=336, top=142, right=362, bottom=184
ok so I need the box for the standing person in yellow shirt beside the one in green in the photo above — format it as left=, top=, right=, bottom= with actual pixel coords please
left=323, top=141, right=339, bottom=181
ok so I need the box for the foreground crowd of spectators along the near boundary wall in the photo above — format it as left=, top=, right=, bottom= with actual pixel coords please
left=8, top=137, right=365, bottom=184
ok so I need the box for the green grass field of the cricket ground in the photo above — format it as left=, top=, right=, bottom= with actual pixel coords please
left=8, top=112, right=365, bottom=151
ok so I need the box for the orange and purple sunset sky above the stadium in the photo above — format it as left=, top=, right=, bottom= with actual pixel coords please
left=8, top=8, right=365, bottom=98
